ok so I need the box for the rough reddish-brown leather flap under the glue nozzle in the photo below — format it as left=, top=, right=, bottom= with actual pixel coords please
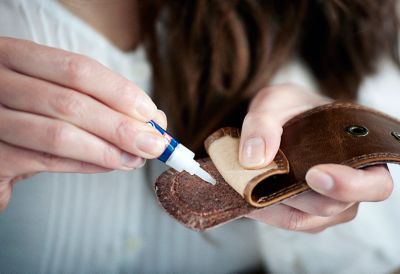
left=155, top=158, right=256, bottom=231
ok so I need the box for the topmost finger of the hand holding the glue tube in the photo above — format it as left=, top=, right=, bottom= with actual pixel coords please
left=0, top=38, right=157, bottom=122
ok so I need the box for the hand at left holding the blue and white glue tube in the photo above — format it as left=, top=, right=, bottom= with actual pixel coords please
left=0, top=37, right=166, bottom=211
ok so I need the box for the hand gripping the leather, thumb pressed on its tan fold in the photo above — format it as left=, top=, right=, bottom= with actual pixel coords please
left=239, top=85, right=393, bottom=233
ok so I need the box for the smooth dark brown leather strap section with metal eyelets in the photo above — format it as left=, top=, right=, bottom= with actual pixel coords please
left=280, top=103, right=400, bottom=200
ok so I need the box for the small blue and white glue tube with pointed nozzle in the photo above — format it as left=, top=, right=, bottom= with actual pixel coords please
left=147, top=120, right=216, bottom=185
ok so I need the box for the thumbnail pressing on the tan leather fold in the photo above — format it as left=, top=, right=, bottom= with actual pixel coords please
left=240, top=137, right=265, bottom=167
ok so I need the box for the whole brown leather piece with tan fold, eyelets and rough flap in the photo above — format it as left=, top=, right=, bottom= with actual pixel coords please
left=155, top=102, right=400, bottom=231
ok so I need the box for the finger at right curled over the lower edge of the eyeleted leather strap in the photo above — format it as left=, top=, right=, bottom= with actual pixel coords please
left=306, top=164, right=393, bottom=202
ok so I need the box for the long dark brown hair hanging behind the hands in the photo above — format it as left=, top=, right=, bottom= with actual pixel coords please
left=139, top=0, right=400, bottom=155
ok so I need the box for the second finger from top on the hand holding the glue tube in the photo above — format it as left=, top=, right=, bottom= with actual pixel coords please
left=0, top=69, right=165, bottom=158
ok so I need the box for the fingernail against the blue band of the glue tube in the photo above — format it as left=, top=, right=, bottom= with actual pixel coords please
left=136, top=132, right=165, bottom=157
